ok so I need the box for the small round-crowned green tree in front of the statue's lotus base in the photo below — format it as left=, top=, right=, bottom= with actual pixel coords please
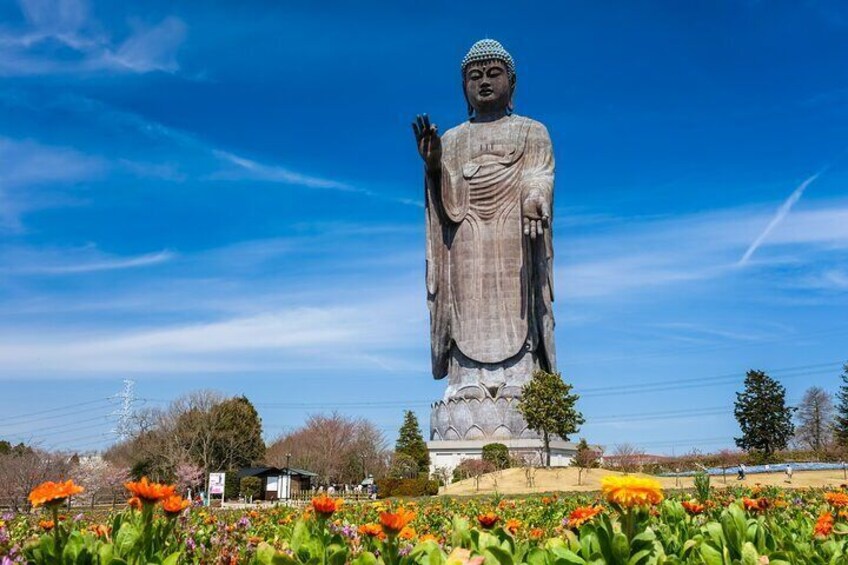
left=518, top=370, right=585, bottom=467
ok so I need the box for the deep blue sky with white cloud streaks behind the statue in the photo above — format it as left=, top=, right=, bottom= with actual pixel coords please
left=0, top=0, right=848, bottom=453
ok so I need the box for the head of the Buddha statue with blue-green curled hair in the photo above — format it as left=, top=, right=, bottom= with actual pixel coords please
left=462, top=39, right=515, bottom=116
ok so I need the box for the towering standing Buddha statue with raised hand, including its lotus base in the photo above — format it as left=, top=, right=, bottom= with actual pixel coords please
left=413, top=40, right=556, bottom=439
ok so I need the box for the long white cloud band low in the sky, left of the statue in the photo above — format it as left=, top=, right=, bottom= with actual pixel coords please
left=0, top=297, right=426, bottom=375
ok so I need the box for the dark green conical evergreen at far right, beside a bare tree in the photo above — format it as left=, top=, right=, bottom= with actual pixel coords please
left=733, top=370, right=795, bottom=460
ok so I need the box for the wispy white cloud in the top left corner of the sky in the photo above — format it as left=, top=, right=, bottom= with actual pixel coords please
left=0, top=0, right=186, bottom=76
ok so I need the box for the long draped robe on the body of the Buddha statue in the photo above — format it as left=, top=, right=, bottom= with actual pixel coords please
left=425, top=115, right=556, bottom=379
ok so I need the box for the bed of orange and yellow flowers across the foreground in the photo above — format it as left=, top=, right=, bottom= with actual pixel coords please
left=0, top=477, right=848, bottom=565
